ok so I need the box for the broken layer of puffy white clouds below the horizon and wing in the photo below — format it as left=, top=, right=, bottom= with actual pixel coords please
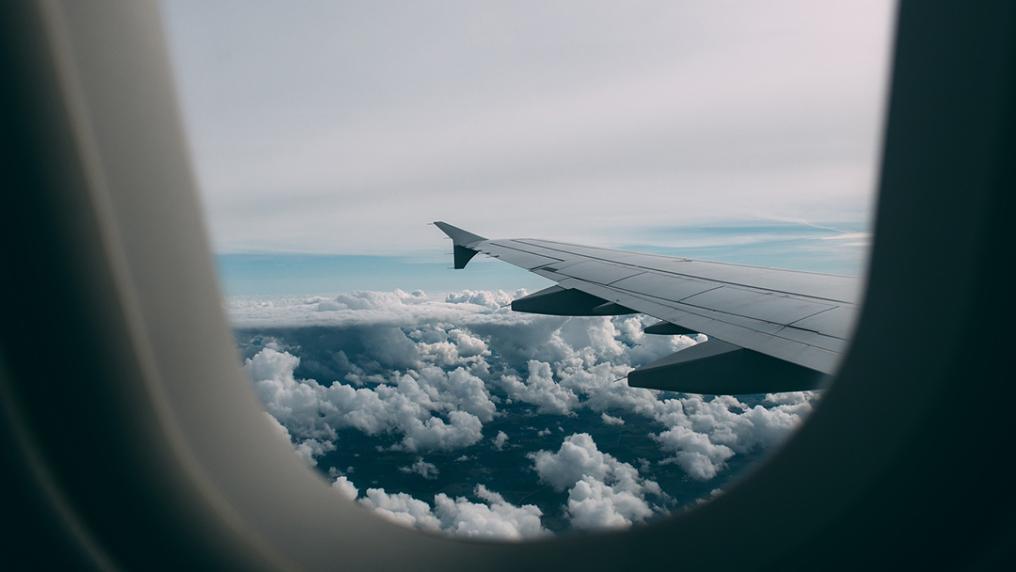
left=237, top=292, right=814, bottom=537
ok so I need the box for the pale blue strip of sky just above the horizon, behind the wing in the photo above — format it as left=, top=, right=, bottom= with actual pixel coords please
left=216, top=223, right=868, bottom=297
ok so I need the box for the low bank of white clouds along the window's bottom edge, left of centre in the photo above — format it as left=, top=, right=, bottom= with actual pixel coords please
left=343, top=476, right=547, bottom=539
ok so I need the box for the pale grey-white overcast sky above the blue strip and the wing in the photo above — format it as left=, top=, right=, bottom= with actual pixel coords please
left=164, top=0, right=893, bottom=255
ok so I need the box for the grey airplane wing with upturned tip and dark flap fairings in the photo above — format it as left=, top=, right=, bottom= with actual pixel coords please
left=435, top=221, right=860, bottom=394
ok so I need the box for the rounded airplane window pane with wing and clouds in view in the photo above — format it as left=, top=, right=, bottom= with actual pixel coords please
left=163, top=0, right=892, bottom=539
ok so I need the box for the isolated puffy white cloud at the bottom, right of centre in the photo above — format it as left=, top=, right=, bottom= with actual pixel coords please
left=529, top=433, right=663, bottom=528
